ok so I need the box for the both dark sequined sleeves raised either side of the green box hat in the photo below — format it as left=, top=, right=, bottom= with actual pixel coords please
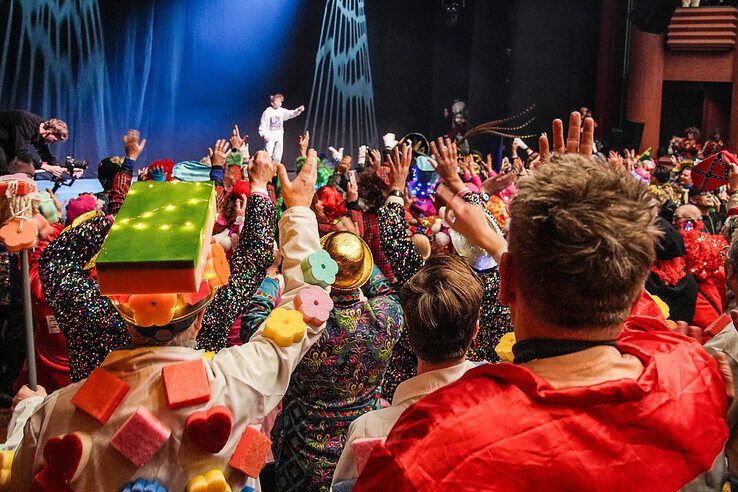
left=39, top=193, right=274, bottom=381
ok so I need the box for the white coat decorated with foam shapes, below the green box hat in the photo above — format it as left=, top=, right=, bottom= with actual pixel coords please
left=10, top=207, right=325, bottom=491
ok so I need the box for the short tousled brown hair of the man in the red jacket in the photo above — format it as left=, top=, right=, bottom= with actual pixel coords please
left=508, top=155, right=660, bottom=328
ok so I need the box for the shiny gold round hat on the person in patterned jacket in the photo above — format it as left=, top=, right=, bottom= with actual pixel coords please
left=320, top=231, right=374, bottom=291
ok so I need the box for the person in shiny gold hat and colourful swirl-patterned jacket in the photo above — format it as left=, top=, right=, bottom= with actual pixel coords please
left=272, top=232, right=402, bottom=490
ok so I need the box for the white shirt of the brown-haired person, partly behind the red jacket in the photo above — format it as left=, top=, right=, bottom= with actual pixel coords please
left=333, top=360, right=477, bottom=485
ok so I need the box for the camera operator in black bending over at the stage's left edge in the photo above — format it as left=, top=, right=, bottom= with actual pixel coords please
left=0, top=109, right=69, bottom=177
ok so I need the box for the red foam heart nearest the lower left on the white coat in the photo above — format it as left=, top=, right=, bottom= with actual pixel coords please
left=43, top=432, right=92, bottom=483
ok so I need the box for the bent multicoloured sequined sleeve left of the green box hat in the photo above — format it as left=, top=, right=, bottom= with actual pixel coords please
left=38, top=212, right=131, bottom=381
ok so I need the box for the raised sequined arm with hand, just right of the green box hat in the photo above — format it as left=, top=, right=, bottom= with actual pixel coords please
left=197, top=151, right=275, bottom=352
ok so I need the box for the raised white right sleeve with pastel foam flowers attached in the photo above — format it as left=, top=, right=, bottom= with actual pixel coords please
left=211, top=207, right=325, bottom=417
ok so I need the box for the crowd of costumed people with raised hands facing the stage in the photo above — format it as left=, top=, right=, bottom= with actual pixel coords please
left=0, top=106, right=738, bottom=491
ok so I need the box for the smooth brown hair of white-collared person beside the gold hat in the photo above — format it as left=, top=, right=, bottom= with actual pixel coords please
left=402, top=255, right=484, bottom=364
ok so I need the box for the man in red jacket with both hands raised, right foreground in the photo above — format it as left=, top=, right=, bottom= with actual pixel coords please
left=354, top=115, right=727, bottom=491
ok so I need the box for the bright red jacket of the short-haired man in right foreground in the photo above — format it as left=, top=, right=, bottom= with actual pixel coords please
left=354, top=315, right=728, bottom=491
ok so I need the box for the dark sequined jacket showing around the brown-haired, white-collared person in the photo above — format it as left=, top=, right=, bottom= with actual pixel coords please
left=379, top=193, right=512, bottom=399
